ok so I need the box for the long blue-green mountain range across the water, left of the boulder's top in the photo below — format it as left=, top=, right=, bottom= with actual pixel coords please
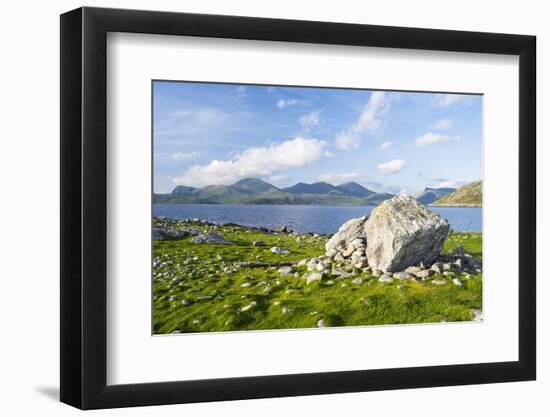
left=153, top=178, right=393, bottom=206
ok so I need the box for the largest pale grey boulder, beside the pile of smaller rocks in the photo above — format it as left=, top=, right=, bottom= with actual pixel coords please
left=365, top=196, right=449, bottom=272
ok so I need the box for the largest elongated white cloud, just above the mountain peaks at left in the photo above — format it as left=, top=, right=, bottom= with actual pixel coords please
left=173, top=137, right=328, bottom=186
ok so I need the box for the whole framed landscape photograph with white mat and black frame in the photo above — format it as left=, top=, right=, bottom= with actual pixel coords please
left=61, top=7, right=536, bottom=409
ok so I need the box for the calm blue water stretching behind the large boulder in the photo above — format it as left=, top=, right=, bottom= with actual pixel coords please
left=153, top=204, right=481, bottom=234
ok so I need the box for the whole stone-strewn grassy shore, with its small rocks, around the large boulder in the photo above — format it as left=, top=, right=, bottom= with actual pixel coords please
left=153, top=210, right=482, bottom=334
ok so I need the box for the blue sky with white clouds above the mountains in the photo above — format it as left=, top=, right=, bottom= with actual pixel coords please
left=153, top=81, right=483, bottom=195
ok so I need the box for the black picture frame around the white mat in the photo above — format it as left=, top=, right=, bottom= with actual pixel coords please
left=60, top=7, right=536, bottom=409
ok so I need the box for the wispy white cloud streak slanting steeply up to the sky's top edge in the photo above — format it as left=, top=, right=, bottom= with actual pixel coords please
left=336, top=91, right=390, bottom=150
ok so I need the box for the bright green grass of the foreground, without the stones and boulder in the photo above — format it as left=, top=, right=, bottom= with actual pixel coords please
left=153, top=223, right=482, bottom=334
